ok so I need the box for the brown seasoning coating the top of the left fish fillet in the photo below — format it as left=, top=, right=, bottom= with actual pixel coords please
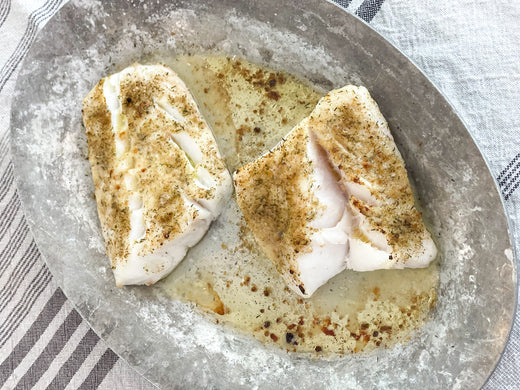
left=83, top=64, right=229, bottom=265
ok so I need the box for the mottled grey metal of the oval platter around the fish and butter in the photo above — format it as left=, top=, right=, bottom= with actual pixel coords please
left=11, top=0, right=516, bottom=389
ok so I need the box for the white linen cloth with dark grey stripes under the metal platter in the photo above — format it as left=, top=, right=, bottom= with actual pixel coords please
left=0, top=0, right=520, bottom=390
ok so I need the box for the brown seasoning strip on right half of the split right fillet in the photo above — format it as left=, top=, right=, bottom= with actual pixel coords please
left=309, top=86, right=429, bottom=263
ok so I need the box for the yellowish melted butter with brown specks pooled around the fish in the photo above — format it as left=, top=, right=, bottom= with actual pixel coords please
left=158, top=56, right=438, bottom=355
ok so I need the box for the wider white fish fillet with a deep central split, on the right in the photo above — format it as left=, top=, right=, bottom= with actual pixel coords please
left=235, top=86, right=437, bottom=297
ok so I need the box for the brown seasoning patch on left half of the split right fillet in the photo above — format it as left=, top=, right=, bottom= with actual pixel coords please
left=234, top=123, right=319, bottom=285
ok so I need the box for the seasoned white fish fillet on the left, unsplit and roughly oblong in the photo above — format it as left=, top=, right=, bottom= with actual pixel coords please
left=83, top=64, right=232, bottom=286
